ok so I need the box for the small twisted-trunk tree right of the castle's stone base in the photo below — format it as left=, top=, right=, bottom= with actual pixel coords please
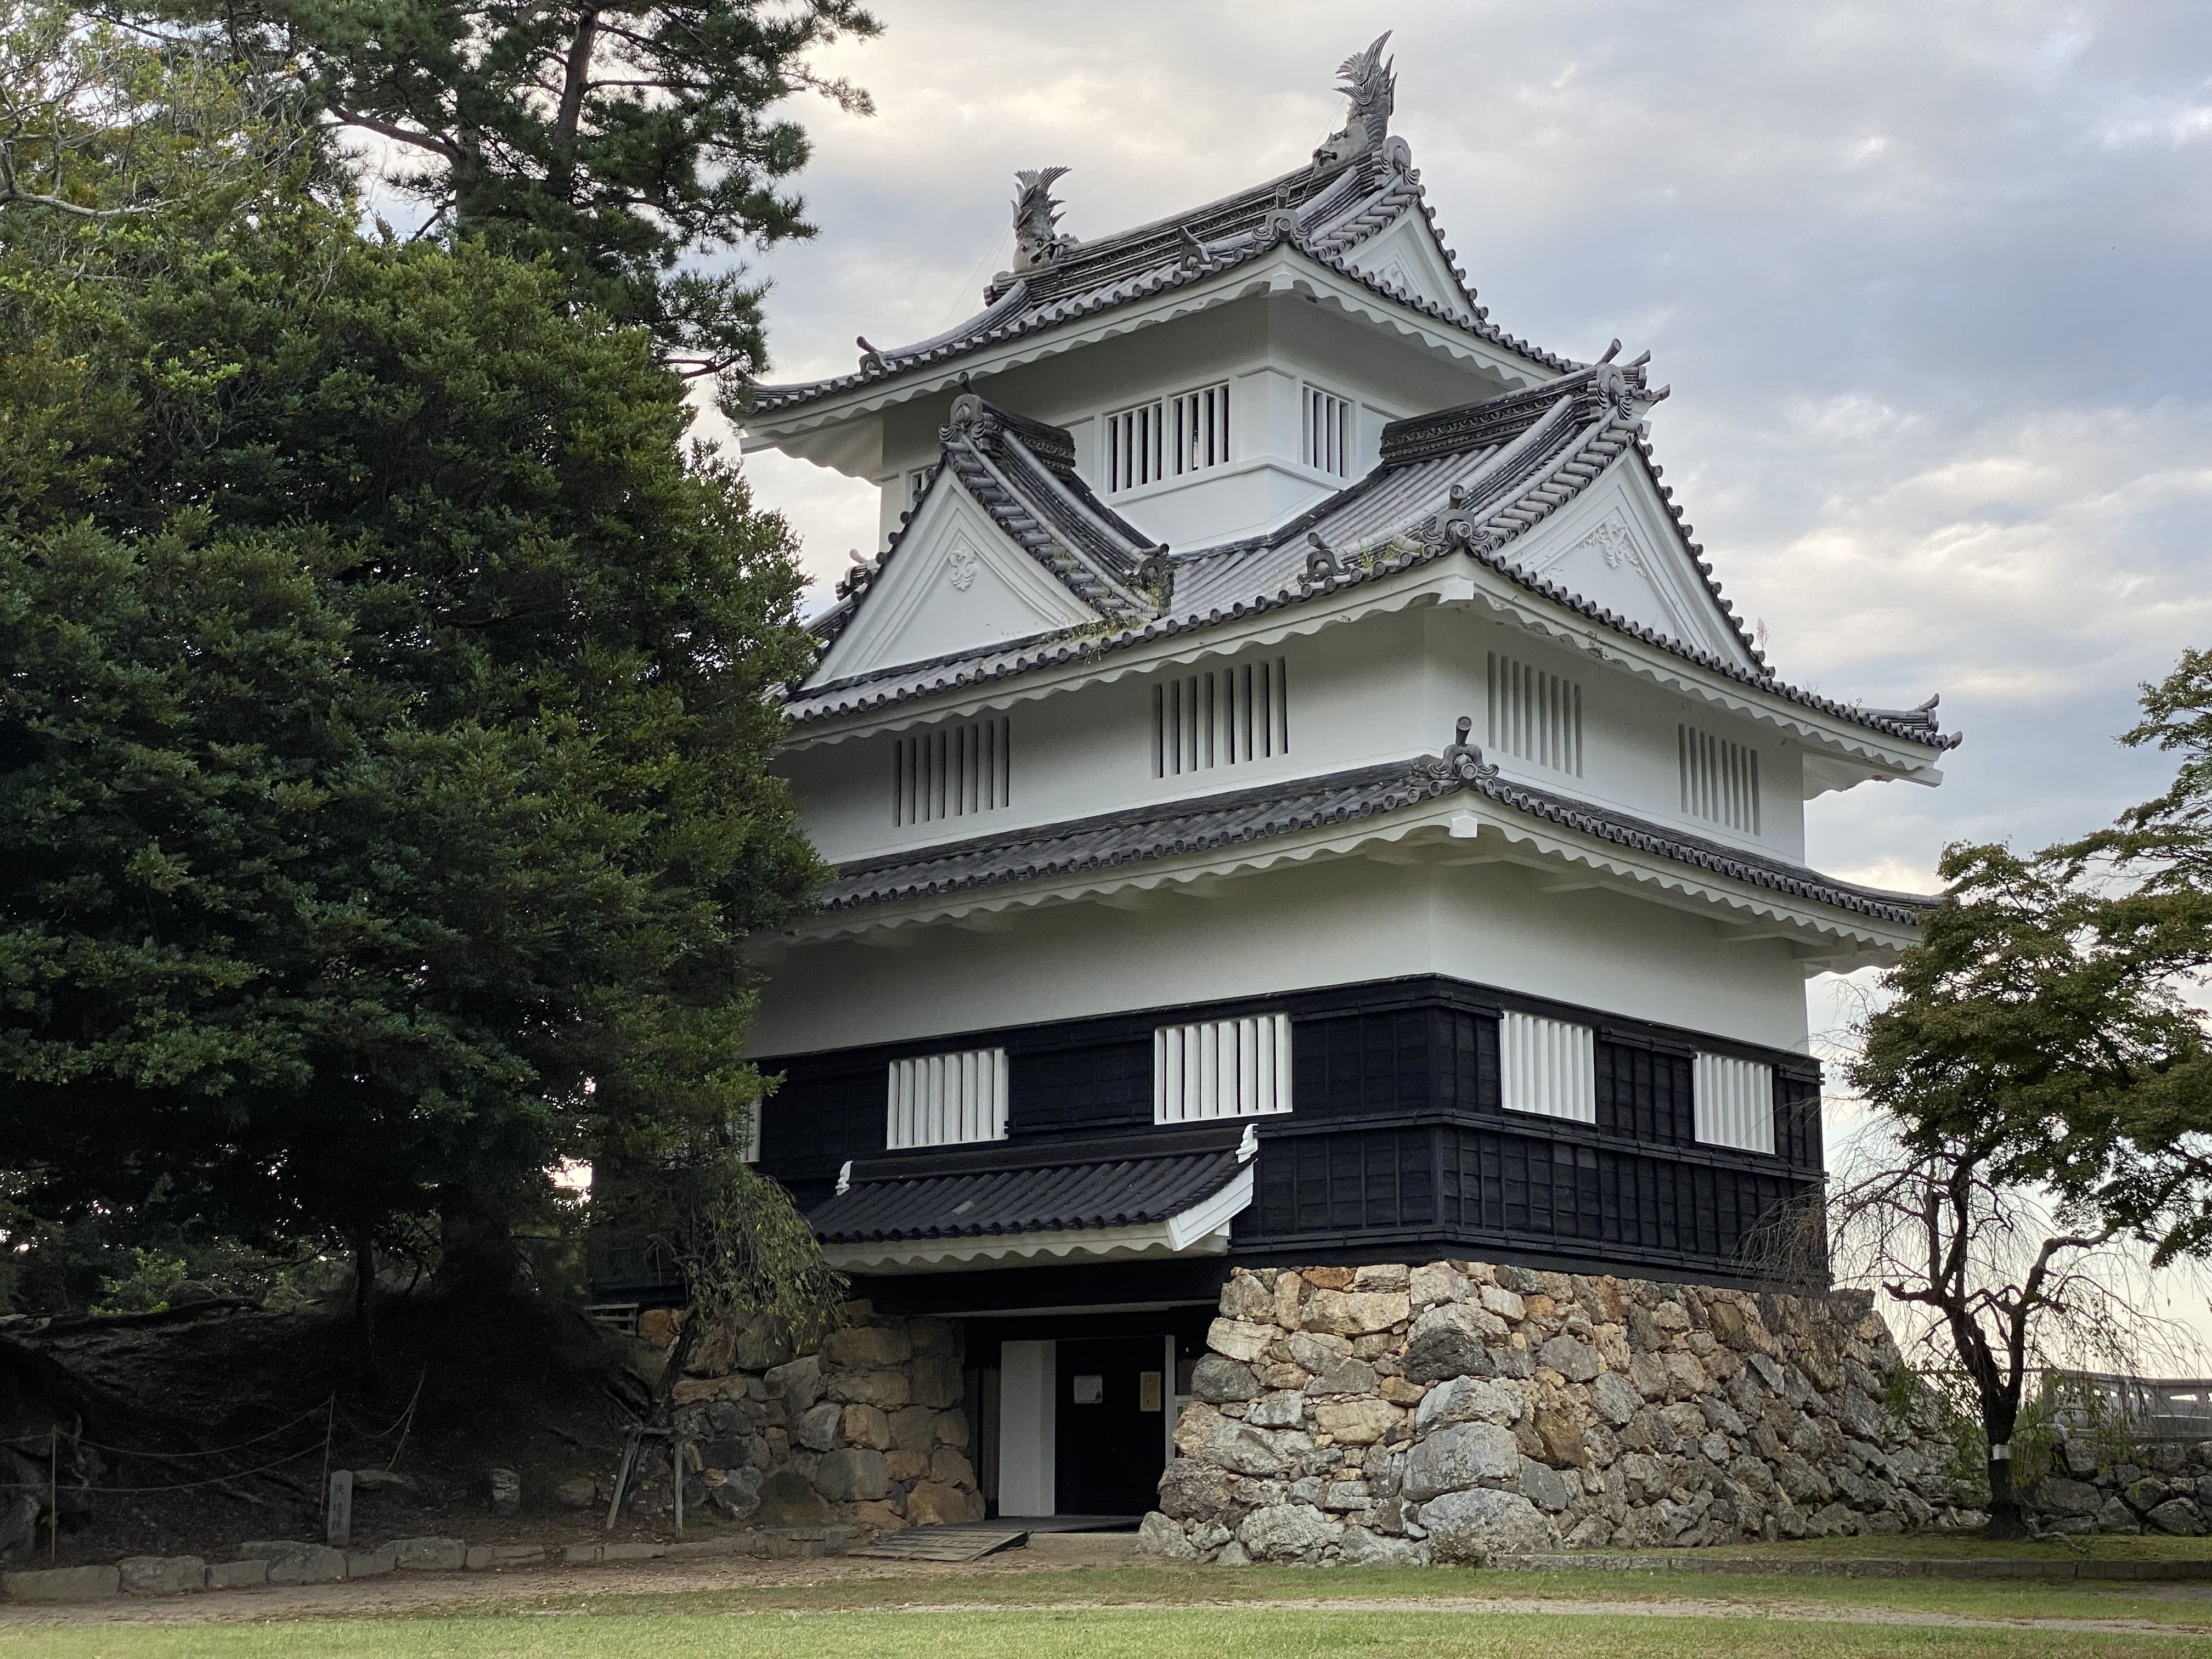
left=1831, top=654, right=2212, bottom=1535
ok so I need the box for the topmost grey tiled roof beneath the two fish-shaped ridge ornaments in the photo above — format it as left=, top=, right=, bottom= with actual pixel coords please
left=752, top=155, right=1577, bottom=416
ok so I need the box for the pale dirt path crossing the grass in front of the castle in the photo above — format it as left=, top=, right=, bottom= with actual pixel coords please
left=13, top=1533, right=2212, bottom=1635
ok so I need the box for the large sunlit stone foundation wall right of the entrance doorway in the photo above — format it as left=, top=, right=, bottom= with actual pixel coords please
left=1142, top=1261, right=1982, bottom=1564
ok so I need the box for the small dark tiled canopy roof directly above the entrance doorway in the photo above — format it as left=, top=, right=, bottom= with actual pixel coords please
left=808, top=1137, right=1243, bottom=1245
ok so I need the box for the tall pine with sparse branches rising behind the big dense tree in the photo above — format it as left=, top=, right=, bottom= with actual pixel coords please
left=124, top=0, right=878, bottom=376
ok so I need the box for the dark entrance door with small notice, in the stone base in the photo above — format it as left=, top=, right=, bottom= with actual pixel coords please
left=1055, top=1336, right=1172, bottom=1515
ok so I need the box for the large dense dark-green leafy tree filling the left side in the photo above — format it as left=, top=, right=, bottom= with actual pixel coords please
left=0, top=6, right=816, bottom=1353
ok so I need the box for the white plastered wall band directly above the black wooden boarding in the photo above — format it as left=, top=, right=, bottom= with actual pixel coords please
left=752, top=858, right=1805, bottom=1055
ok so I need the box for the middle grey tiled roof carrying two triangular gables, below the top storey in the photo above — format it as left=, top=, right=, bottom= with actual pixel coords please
left=785, top=374, right=1960, bottom=748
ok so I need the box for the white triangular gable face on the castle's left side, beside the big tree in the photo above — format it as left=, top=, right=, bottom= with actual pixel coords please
left=808, top=479, right=1102, bottom=686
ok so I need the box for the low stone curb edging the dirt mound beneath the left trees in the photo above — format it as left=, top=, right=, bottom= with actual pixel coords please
left=0, top=1526, right=851, bottom=1601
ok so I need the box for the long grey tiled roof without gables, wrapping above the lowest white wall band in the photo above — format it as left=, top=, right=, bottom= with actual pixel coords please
left=823, top=750, right=1933, bottom=922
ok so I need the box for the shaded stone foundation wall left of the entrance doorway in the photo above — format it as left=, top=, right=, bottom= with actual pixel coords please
left=624, top=1303, right=982, bottom=1531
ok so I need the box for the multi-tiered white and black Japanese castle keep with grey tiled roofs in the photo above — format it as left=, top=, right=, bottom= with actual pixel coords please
left=703, top=42, right=1957, bottom=1560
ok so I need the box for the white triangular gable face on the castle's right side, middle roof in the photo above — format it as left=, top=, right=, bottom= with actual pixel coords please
left=1511, top=456, right=1758, bottom=670
